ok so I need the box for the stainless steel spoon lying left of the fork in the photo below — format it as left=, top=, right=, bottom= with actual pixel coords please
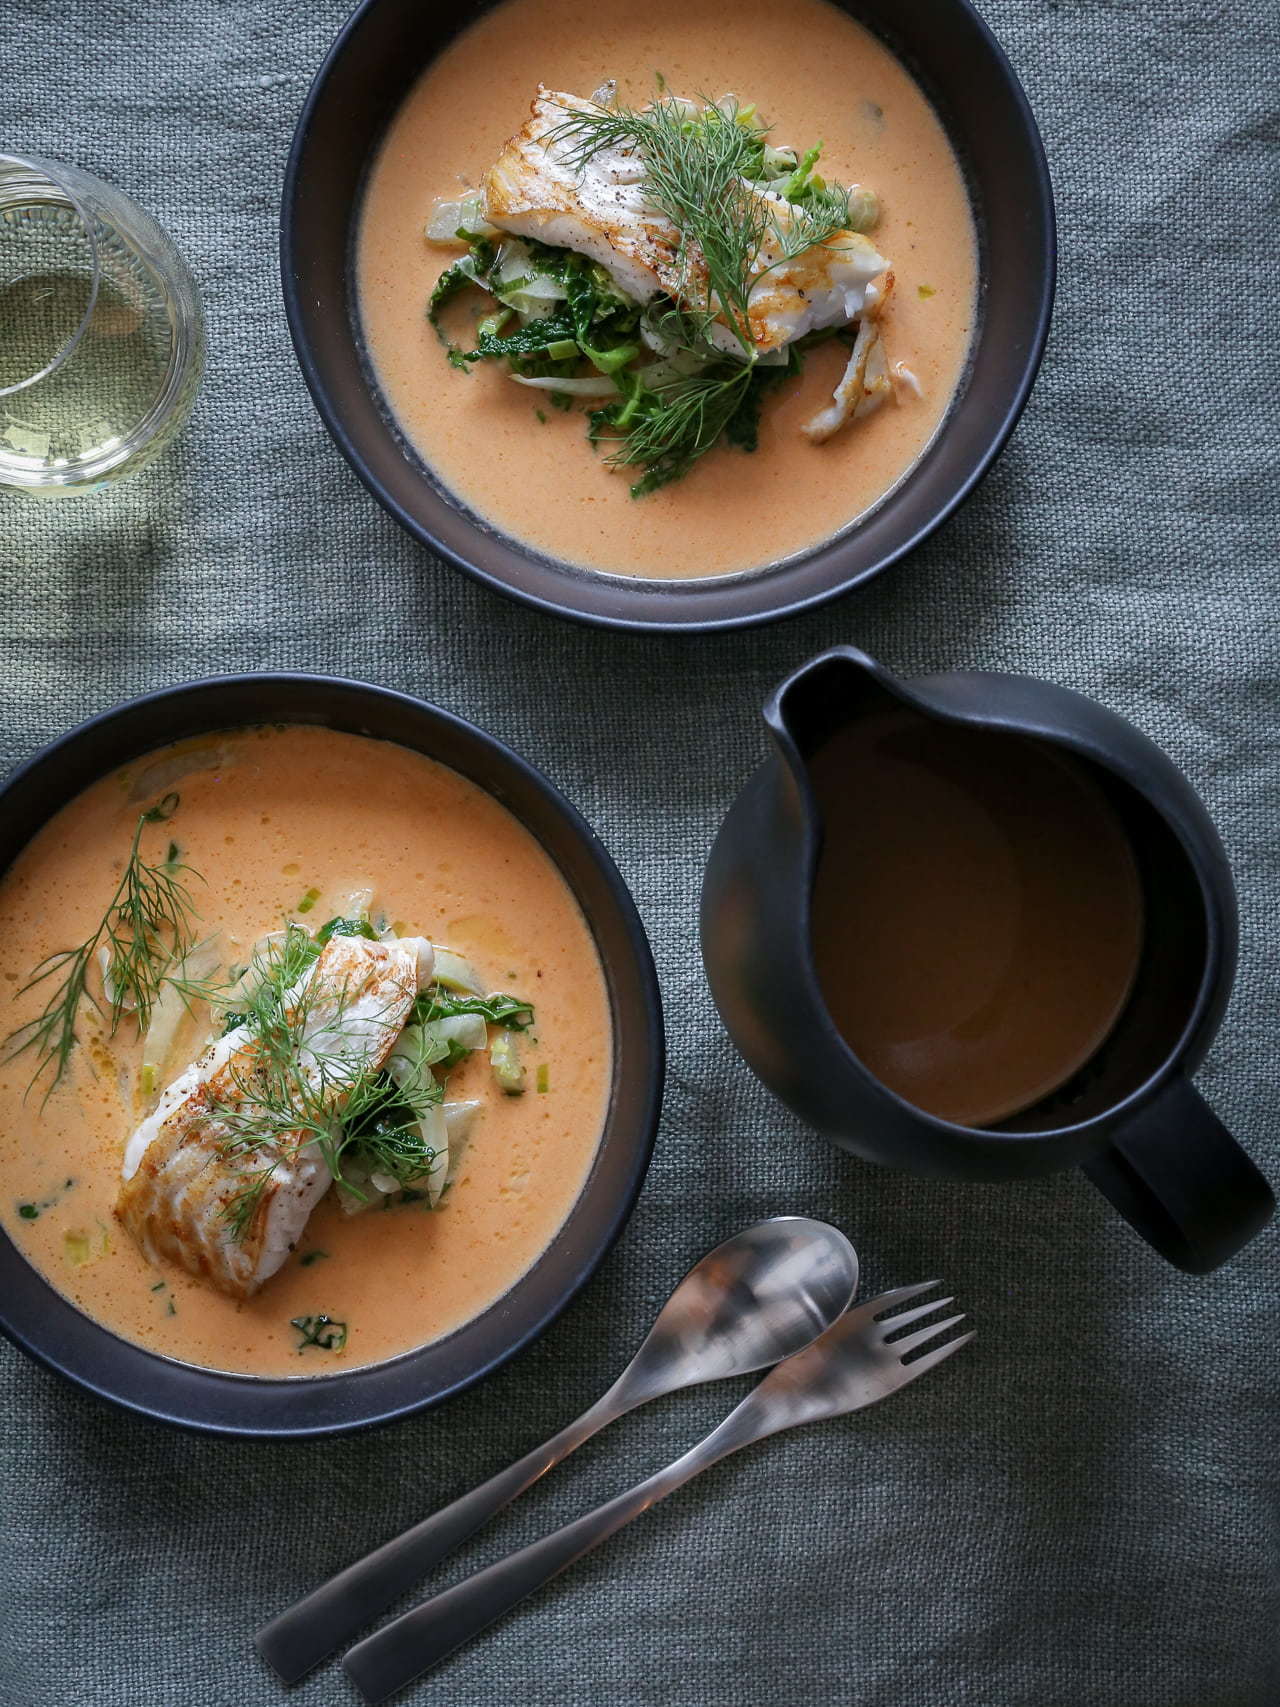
left=254, top=1215, right=858, bottom=1683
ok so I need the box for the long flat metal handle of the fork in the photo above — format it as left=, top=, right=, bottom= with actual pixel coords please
left=343, top=1412, right=758, bottom=1702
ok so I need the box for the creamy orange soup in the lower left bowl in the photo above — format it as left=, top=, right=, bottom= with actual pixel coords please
left=0, top=727, right=611, bottom=1376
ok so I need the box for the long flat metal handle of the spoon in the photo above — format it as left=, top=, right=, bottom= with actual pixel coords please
left=254, top=1384, right=628, bottom=1683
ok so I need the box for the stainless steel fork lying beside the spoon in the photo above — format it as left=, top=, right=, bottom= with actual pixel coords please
left=343, top=1280, right=973, bottom=1702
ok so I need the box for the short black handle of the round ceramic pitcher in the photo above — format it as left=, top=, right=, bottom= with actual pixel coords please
left=1084, top=1074, right=1275, bottom=1275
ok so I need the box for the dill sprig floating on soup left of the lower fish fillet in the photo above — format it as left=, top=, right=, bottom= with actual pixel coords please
left=5, top=794, right=205, bottom=1099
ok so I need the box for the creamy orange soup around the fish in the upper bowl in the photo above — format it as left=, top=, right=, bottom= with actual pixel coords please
left=357, top=0, right=976, bottom=577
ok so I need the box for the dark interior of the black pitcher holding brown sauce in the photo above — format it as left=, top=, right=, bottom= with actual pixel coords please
left=811, top=710, right=1142, bottom=1127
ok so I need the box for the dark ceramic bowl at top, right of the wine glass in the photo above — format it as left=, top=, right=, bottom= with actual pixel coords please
left=282, top=0, right=1055, bottom=630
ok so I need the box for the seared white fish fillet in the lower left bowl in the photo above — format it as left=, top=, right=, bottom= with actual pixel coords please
left=116, top=937, right=433, bottom=1297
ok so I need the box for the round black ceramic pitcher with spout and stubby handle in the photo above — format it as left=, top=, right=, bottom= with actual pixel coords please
left=701, top=647, right=1275, bottom=1273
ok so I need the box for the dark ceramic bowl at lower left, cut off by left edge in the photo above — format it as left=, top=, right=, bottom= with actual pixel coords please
left=0, top=674, right=662, bottom=1437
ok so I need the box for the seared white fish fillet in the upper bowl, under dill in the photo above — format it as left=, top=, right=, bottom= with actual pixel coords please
left=481, top=85, right=889, bottom=355
